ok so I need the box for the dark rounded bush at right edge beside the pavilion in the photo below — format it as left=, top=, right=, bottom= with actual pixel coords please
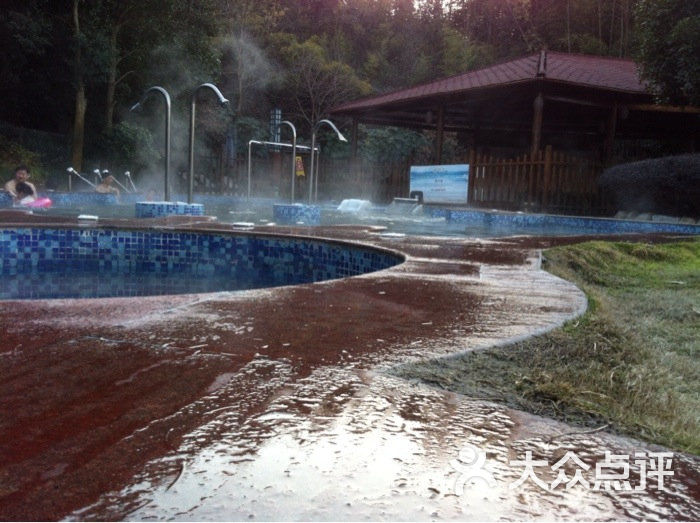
left=599, top=154, right=700, bottom=219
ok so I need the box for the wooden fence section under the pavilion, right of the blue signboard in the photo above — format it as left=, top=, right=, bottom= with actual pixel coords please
left=468, top=147, right=606, bottom=214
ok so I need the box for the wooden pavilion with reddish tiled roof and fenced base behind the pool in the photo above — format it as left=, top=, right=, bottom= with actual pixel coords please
left=331, top=51, right=700, bottom=213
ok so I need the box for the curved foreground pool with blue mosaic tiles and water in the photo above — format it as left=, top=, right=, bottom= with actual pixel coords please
left=0, top=227, right=404, bottom=300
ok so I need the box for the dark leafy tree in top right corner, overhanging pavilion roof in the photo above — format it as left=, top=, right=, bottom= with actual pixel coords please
left=634, top=0, right=700, bottom=105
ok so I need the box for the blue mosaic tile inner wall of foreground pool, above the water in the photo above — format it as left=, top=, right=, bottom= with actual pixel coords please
left=0, top=227, right=404, bottom=299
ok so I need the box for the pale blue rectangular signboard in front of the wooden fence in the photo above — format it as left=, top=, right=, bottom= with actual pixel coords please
left=411, top=164, right=469, bottom=204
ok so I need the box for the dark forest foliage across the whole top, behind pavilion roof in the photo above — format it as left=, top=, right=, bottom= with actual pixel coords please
left=0, top=0, right=700, bottom=176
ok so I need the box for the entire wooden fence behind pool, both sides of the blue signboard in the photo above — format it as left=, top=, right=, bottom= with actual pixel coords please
left=183, top=147, right=607, bottom=215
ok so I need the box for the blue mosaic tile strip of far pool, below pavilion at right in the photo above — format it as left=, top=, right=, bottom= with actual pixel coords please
left=426, top=207, right=700, bottom=234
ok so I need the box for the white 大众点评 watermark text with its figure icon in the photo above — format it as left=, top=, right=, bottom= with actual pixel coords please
left=450, top=445, right=674, bottom=496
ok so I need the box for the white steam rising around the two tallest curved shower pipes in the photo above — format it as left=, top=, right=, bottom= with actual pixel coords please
left=121, top=33, right=279, bottom=198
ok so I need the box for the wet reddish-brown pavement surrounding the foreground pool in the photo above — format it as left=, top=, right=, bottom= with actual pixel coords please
left=0, top=214, right=700, bottom=520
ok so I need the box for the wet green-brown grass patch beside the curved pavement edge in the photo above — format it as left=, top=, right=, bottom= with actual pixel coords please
left=395, top=240, right=700, bottom=454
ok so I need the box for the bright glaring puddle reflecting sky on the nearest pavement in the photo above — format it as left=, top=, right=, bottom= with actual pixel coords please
left=71, top=361, right=700, bottom=520
